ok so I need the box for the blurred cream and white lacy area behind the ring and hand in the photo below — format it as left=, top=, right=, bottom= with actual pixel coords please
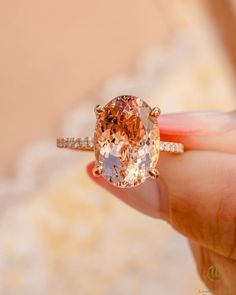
left=0, top=12, right=236, bottom=295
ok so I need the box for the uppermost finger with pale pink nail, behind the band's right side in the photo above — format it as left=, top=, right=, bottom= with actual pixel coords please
left=159, top=112, right=236, bottom=153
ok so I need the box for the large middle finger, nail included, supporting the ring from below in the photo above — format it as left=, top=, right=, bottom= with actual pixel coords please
left=89, top=151, right=236, bottom=259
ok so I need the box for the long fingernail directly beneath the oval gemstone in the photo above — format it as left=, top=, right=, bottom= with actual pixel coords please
left=87, top=162, right=168, bottom=221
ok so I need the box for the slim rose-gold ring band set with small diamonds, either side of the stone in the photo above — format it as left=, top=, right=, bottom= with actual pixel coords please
left=57, top=137, right=184, bottom=154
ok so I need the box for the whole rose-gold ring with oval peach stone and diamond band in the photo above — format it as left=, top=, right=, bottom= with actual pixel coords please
left=57, top=95, right=184, bottom=188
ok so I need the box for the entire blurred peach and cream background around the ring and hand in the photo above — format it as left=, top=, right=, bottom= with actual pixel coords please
left=0, top=0, right=236, bottom=295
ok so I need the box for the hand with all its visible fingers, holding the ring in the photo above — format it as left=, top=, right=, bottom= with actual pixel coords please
left=87, top=112, right=236, bottom=295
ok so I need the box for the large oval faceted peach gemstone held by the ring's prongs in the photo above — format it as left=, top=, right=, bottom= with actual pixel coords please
left=94, top=96, right=160, bottom=188
